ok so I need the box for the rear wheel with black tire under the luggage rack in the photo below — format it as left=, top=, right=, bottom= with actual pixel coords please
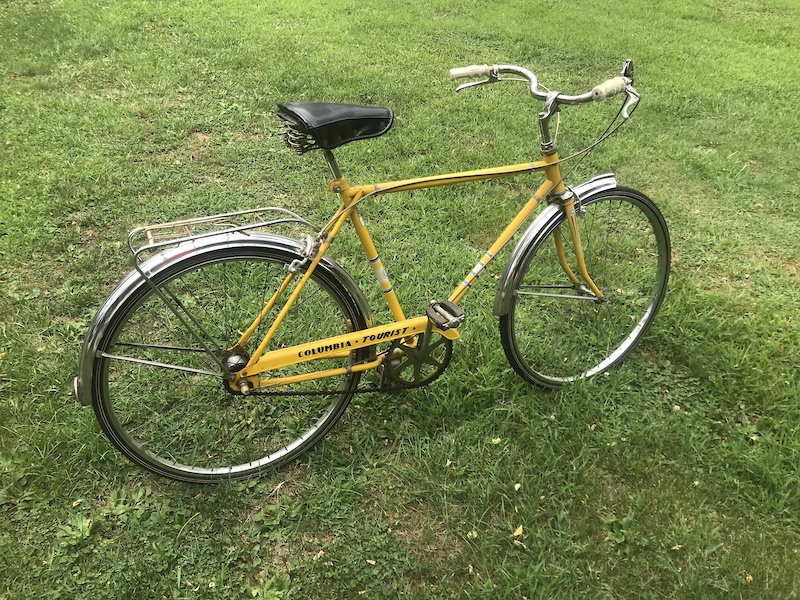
left=92, top=241, right=369, bottom=483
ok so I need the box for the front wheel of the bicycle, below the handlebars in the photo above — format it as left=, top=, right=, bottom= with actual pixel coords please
left=500, top=187, right=670, bottom=388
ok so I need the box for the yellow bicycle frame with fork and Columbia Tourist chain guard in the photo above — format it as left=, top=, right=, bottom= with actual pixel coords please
left=229, top=152, right=602, bottom=390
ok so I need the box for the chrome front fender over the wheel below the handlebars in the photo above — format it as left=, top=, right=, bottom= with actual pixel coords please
left=492, top=173, right=617, bottom=317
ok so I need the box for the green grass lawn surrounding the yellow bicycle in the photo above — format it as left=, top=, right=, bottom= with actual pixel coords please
left=0, top=0, right=800, bottom=599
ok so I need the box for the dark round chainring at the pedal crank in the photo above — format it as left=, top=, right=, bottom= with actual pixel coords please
left=383, top=333, right=453, bottom=388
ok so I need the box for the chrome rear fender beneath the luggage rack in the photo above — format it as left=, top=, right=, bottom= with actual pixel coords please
left=74, top=232, right=374, bottom=406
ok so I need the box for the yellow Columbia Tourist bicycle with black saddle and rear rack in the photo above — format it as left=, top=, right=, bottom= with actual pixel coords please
left=75, top=61, right=670, bottom=482
